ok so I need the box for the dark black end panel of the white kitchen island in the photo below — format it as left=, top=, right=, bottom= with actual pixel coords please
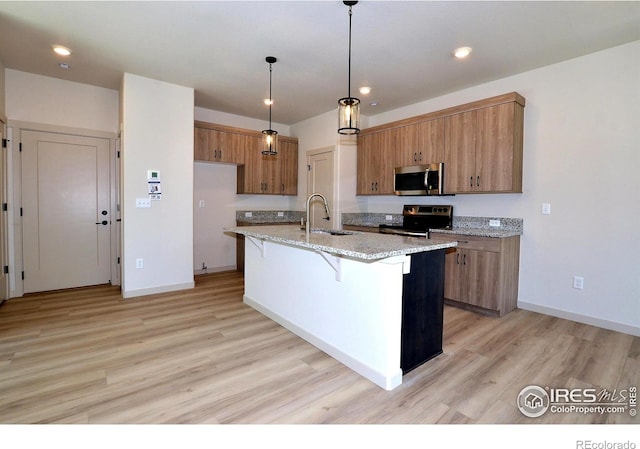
left=400, top=250, right=445, bottom=375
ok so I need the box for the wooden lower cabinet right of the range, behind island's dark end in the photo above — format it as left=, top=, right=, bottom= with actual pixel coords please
left=431, top=232, right=520, bottom=316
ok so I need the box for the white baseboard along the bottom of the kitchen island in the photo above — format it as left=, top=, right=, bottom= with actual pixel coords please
left=243, top=295, right=402, bottom=390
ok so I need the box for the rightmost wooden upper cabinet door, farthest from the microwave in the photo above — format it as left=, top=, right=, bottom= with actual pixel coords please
left=476, top=103, right=521, bottom=192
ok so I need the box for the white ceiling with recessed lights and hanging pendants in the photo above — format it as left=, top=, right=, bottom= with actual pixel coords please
left=0, top=0, right=640, bottom=124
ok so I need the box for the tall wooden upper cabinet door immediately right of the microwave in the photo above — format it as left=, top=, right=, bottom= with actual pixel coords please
left=444, top=111, right=476, bottom=193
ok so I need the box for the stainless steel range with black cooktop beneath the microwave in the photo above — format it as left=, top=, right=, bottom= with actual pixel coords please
left=379, top=204, right=453, bottom=238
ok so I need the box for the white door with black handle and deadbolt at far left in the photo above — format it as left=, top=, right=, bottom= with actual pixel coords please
left=21, top=131, right=111, bottom=293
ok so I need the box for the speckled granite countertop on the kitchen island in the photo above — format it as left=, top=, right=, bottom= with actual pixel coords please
left=224, top=225, right=457, bottom=261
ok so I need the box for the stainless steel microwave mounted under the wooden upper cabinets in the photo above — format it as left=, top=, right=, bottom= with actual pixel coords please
left=393, top=162, right=444, bottom=195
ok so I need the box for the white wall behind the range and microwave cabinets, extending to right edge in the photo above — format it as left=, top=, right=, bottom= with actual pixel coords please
left=293, top=42, right=640, bottom=335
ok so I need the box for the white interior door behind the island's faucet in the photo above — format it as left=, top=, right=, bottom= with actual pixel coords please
left=305, top=147, right=338, bottom=229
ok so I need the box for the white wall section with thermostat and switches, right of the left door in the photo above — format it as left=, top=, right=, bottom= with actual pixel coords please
left=121, top=73, right=194, bottom=298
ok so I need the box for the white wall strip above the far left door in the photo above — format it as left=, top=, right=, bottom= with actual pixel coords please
left=5, top=69, right=119, bottom=134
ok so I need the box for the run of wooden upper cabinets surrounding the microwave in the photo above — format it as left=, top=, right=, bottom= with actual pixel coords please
left=356, top=92, right=525, bottom=195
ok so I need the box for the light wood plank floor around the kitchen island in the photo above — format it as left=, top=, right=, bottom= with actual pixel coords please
left=0, top=272, right=640, bottom=424
